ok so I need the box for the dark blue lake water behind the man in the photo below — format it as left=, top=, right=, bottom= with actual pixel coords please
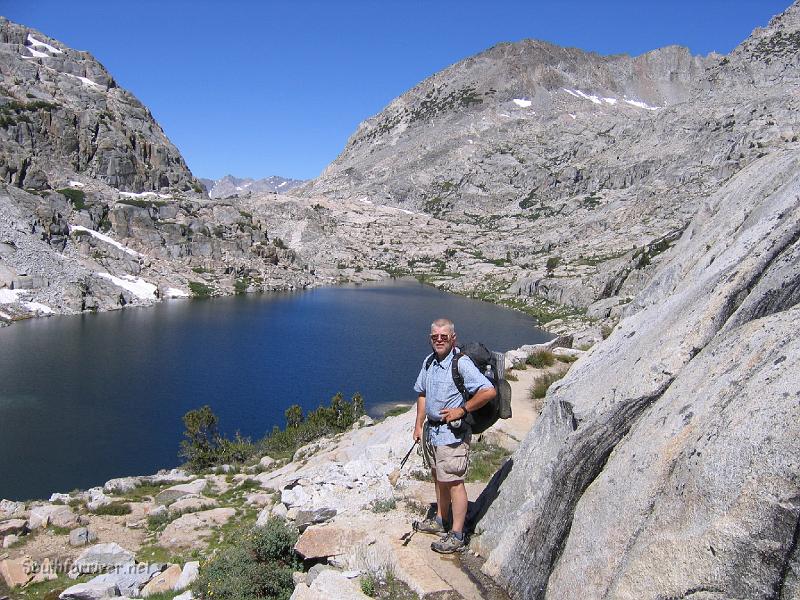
left=0, top=282, right=548, bottom=499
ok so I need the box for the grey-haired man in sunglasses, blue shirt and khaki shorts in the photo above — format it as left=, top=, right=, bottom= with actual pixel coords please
left=414, top=319, right=495, bottom=554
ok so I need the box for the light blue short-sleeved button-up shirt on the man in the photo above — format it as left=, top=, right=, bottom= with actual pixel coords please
left=414, top=352, right=493, bottom=446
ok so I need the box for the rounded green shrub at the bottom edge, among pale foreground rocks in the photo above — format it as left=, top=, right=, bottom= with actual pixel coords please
left=192, top=518, right=301, bottom=600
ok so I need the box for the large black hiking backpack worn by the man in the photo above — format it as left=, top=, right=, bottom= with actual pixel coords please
left=425, top=342, right=511, bottom=433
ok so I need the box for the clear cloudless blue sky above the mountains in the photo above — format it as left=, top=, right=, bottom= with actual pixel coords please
left=0, top=0, right=791, bottom=179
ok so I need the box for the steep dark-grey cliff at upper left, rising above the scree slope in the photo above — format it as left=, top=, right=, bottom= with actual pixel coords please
left=0, top=18, right=200, bottom=192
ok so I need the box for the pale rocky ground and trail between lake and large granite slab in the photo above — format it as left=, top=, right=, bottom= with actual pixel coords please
left=0, top=345, right=584, bottom=600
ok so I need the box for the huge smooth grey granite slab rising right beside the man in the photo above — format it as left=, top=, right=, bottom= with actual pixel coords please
left=472, top=147, right=800, bottom=599
